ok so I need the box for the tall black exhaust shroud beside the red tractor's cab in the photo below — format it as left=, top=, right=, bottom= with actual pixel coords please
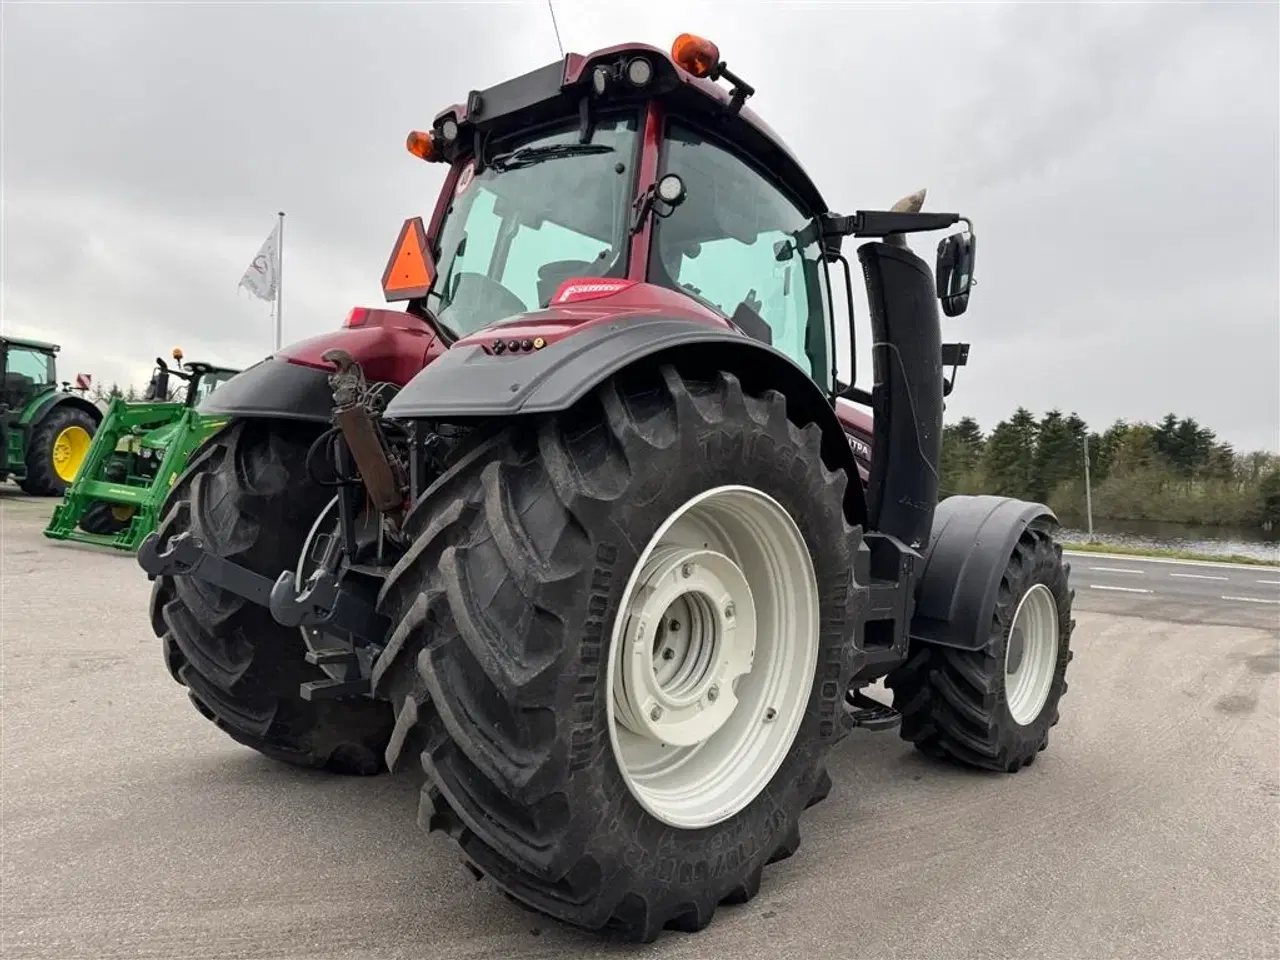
left=858, top=243, right=943, bottom=552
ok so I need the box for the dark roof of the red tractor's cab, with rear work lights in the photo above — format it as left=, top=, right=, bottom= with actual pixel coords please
left=434, top=44, right=828, bottom=214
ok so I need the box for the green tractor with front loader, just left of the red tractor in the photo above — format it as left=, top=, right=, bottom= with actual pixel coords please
left=45, top=349, right=239, bottom=552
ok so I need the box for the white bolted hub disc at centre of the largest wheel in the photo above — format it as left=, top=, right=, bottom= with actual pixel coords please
left=614, top=547, right=755, bottom=746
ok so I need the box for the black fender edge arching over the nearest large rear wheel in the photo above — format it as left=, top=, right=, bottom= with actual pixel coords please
left=387, top=316, right=867, bottom=524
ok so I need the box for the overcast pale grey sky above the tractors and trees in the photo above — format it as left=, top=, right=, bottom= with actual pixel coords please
left=0, top=0, right=1280, bottom=449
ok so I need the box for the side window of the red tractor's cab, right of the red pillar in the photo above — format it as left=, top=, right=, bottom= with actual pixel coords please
left=649, top=122, right=832, bottom=389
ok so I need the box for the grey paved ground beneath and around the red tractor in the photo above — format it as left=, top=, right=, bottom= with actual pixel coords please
left=0, top=495, right=1280, bottom=960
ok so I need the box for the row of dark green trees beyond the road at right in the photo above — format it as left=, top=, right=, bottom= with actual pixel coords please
left=940, top=407, right=1280, bottom=530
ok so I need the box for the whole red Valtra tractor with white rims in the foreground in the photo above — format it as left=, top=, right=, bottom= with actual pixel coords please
left=138, top=35, right=1074, bottom=941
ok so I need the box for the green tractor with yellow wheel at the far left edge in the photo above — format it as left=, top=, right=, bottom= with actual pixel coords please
left=0, top=337, right=102, bottom=497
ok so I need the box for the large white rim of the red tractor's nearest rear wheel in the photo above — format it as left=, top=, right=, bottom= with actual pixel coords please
left=607, top=486, right=819, bottom=829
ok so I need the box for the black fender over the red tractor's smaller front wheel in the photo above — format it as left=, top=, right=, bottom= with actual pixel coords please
left=910, top=497, right=1059, bottom=650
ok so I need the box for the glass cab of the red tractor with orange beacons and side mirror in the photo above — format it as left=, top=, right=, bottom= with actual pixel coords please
left=384, top=33, right=973, bottom=402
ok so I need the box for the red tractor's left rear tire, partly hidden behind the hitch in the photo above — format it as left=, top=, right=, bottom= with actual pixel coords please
left=151, top=420, right=394, bottom=774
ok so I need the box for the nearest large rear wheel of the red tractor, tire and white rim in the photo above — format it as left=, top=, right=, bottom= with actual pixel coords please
left=374, top=367, right=858, bottom=941
